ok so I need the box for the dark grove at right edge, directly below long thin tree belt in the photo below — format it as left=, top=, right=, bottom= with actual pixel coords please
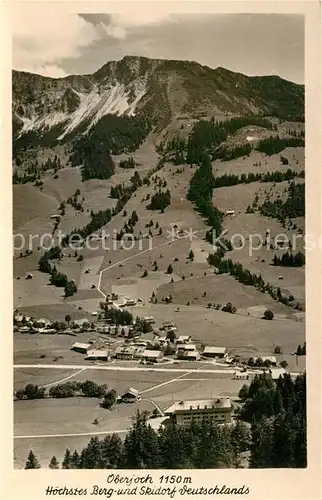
left=259, top=181, right=305, bottom=223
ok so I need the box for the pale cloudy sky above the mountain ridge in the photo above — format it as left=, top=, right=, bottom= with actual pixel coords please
left=12, top=4, right=304, bottom=84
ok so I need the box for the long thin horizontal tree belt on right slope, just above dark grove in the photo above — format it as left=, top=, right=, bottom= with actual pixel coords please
left=215, top=168, right=305, bottom=187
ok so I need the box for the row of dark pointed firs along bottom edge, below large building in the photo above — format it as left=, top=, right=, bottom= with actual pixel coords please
left=26, top=412, right=250, bottom=469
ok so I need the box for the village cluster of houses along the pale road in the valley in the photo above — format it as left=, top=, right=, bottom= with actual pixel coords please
left=14, top=294, right=295, bottom=380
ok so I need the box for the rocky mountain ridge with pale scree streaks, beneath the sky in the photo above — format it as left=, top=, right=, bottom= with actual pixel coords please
left=12, top=56, right=304, bottom=149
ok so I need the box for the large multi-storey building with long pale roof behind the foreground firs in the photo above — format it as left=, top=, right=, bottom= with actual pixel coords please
left=164, top=398, right=233, bottom=427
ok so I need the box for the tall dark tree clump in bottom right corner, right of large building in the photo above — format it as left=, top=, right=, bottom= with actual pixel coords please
left=240, top=374, right=307, bottom=468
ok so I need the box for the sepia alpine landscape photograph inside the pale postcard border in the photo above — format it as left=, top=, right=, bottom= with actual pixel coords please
left=10, top=2, right=307, bottom=474
